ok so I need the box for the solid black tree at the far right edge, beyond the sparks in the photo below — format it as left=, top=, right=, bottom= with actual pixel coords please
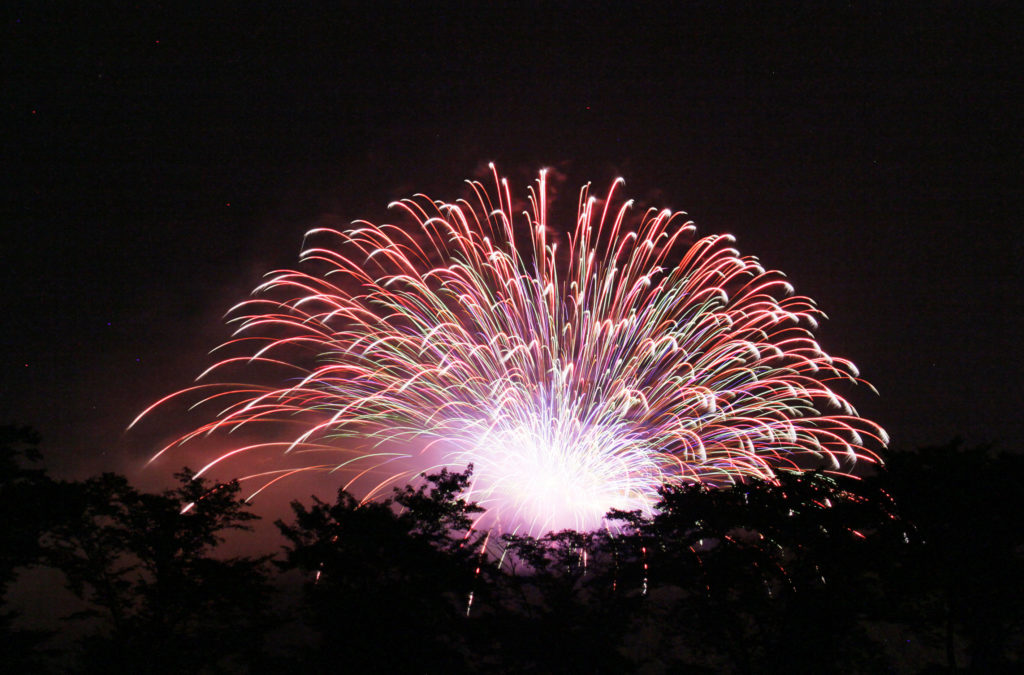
left=886, top=440, right=1024, bottom=673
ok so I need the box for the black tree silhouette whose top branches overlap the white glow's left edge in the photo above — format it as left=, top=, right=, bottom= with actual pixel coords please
left=278, top=470, right=484, bottom=672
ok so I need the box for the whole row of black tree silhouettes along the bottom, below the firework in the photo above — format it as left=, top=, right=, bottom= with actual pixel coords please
left=0, top=427, right=1024, bottom=673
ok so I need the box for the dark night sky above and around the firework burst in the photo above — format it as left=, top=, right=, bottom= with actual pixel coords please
left=0, top=2, right=1024, bottom=483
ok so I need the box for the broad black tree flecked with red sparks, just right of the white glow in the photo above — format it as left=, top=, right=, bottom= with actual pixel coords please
left=598, top=472, right=901, bottom=673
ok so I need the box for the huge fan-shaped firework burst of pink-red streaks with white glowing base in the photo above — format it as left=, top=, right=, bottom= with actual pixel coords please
left=140, top=166, right=887, bottom=534
